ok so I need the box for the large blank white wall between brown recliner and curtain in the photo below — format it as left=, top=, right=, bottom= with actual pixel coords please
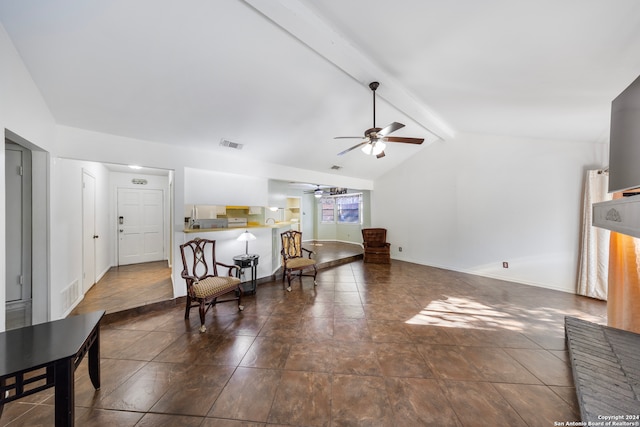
left=371, top=134, right=606, bottom=292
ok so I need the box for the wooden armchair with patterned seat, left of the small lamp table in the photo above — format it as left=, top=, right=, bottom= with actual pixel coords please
left=180, top=238, right=244, bottom=332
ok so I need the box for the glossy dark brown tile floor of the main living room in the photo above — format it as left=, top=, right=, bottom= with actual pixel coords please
left=0, top=261, right=606, bottom=427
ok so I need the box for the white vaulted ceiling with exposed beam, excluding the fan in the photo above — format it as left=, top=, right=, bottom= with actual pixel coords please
left=0, top=0, right=640, bottom=179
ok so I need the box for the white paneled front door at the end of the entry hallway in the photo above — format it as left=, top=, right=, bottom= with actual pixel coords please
left=118, top=188, right=164, bottom=265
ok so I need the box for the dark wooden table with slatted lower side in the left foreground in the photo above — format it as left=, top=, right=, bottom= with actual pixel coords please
left=0, top=311, right=104, bottom=427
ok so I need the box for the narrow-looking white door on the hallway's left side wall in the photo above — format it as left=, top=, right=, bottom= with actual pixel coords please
left=82, top=171, right=98, bottom=292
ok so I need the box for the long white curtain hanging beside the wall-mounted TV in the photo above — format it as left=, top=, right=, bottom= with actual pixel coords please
left=577, top=170, right=611, bottom=300
